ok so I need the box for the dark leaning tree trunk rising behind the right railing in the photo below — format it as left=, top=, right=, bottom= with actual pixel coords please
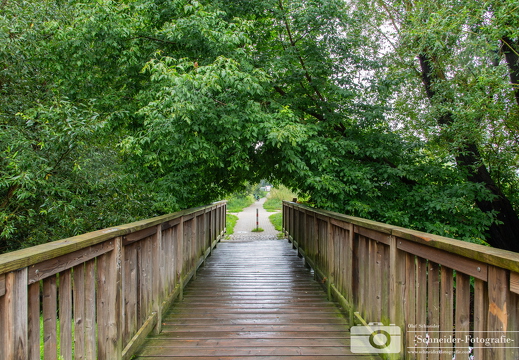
left=418, top=53, right=519, bottom=252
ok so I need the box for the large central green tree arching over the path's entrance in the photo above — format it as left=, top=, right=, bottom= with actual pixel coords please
left=135, top=1, right=504, bottom=245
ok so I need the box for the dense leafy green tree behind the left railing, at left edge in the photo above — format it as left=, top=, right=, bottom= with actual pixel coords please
left=0, top=0, right=178, bottom=251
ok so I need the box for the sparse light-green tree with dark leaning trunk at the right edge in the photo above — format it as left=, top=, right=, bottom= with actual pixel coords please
left=364, top=1, right=519, bottom=251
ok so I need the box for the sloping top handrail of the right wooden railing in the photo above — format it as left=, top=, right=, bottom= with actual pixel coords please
left=283, top=201, right=519, bottom=272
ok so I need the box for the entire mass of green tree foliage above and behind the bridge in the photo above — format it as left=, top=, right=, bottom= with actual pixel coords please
left=0, top=0, right=519, bottom=251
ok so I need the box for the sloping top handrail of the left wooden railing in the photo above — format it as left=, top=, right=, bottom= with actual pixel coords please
left=0, top=200, right=225, bottom=274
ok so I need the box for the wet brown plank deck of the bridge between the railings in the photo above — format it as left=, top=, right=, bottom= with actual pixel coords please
left=136, top=239, right=369, bottom=360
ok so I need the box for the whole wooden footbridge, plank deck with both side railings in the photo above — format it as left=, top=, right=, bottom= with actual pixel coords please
left=0, top=202, right=519, bottom=360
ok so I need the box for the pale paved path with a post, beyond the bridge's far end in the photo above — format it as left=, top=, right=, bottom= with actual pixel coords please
left=229, top=198, right=279, bottom=241
